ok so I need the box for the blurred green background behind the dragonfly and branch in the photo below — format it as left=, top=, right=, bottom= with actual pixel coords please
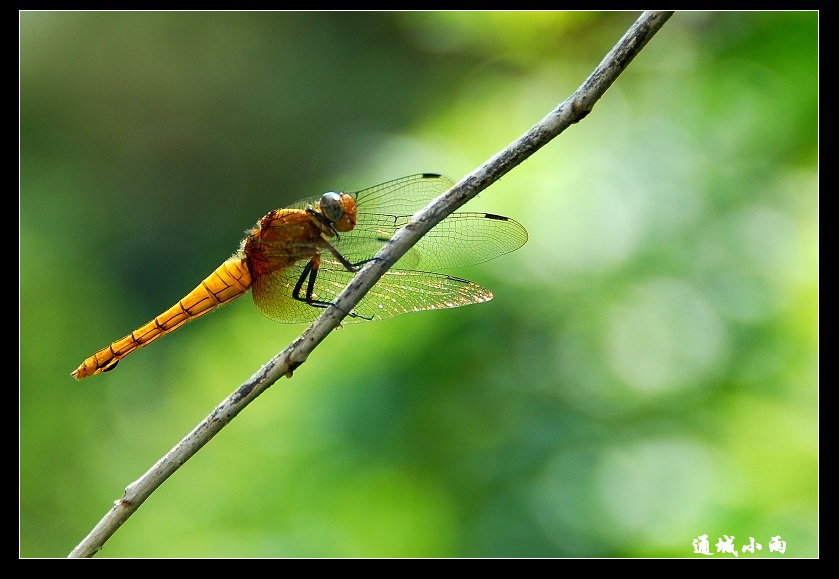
left=20, top=12, right=819, bottom=559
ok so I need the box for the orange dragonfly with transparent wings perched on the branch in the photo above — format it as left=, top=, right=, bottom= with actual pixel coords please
left=72, top=173, right=527, bottom=380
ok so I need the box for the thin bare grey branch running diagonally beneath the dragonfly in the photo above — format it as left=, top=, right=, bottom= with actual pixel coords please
left=69, top=12, right=672, bottom=557
